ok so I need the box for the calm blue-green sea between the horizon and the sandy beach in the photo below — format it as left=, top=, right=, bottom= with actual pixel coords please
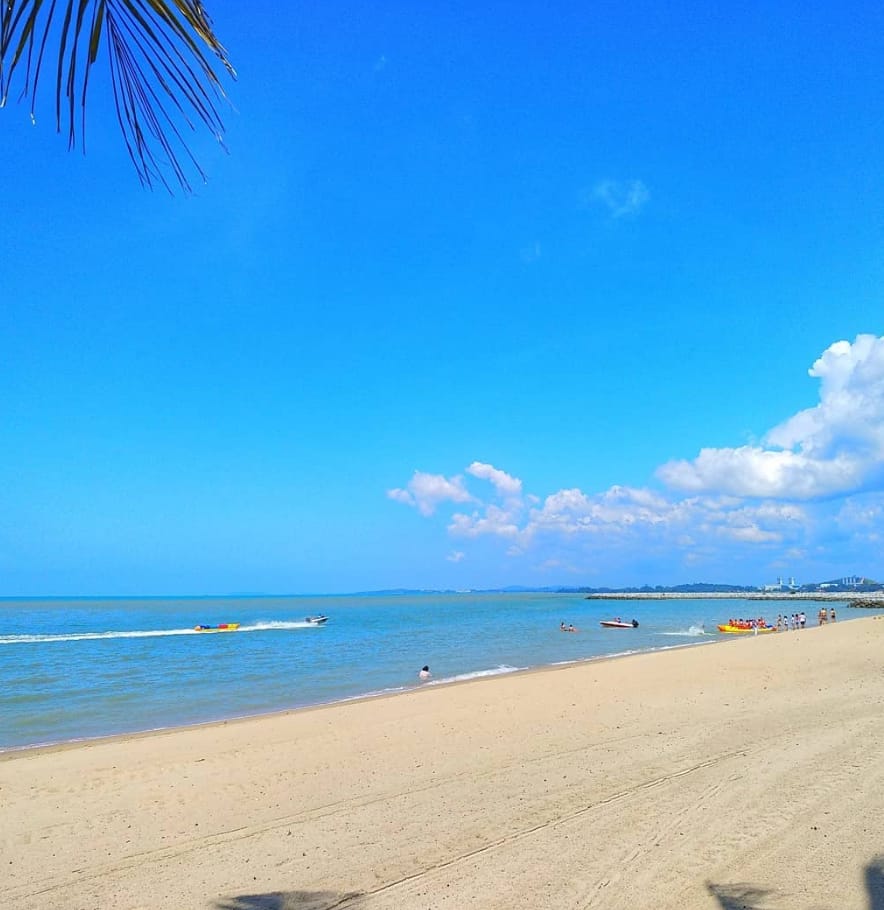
left=0, top=594, right=869, bottom=749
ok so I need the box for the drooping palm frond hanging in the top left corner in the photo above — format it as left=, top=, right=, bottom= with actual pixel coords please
left=0, top=0, right=236, bottom=192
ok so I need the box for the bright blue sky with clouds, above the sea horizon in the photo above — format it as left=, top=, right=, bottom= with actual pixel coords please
left=0, top=0, right=884, bottom=595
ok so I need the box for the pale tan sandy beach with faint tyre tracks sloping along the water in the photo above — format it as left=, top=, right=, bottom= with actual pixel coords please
left=0, top=617, right=884, bottom=910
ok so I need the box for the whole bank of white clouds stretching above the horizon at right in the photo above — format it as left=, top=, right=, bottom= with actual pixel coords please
left=387, top=335, right=884, bottom=584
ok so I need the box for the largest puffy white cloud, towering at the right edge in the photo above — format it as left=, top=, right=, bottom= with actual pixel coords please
left=657, top=335, right=884, bottom=500
